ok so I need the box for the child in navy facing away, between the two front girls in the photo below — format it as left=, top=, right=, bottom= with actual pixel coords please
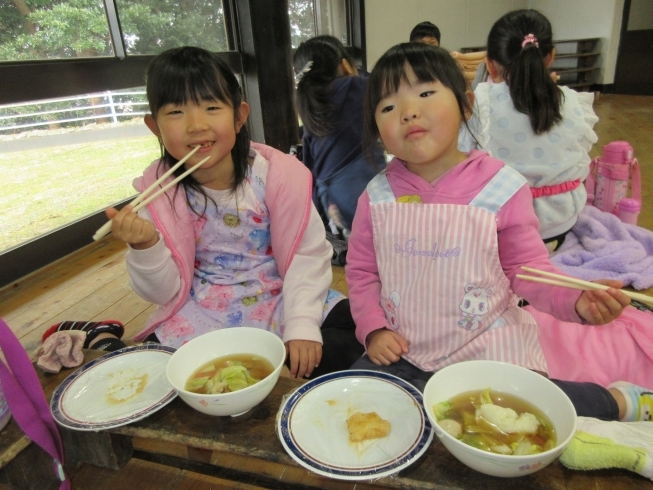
left=293, top=36, right=385, bottom=243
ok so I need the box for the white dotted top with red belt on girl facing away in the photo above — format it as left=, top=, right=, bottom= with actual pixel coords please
left=470, top=82, right=598, bottom=239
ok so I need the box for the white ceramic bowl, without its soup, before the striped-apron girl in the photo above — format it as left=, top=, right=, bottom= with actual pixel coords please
left=424, top=361, right=576, bottom=477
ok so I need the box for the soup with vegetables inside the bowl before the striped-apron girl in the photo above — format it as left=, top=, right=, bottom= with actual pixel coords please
left=433, top=389, right=556, bottom=455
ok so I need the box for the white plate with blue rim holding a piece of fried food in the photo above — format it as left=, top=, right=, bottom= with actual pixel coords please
left=277, top=370, right=433, bottom=480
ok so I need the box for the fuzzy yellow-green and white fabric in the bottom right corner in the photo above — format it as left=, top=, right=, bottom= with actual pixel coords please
left=560, top=417, right=653, bottom=480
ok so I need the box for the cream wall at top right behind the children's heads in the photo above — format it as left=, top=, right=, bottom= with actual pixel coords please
left=365, top=0, right=624, bottom=84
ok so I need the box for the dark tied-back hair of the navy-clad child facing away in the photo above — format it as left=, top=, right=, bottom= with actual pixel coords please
left=293, top=36, right=355, bottom=137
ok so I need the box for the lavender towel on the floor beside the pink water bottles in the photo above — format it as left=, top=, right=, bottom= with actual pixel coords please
left=551, top=206, right=653, bottom=289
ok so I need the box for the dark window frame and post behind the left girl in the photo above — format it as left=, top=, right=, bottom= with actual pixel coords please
left=0, top=0, right=365, bottom=287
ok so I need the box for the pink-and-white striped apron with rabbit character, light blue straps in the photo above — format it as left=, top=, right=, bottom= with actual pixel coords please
left=367, top=166, right=547, bottom=372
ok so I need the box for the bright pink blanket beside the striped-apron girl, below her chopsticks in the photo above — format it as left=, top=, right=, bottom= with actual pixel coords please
left=525, top=306, right=653, bottom=390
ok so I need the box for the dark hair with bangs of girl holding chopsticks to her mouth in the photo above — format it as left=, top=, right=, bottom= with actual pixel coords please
left=146, top=46, right=249, bottom=214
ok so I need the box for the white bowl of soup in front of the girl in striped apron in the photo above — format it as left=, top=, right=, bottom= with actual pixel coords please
left=424, top=361, right=576, bottom=477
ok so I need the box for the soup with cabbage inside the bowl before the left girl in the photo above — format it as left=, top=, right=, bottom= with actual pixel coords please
left=184, top=354, right=274, bottom=394
